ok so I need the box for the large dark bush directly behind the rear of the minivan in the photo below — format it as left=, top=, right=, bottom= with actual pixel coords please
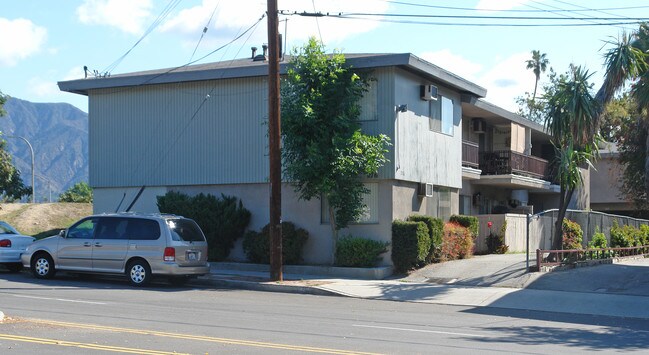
left=157, top=191, right=250, bottom=261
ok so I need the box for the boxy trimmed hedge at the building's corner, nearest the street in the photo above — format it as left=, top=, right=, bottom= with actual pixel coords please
left=392, top=220, right=431, bottom=272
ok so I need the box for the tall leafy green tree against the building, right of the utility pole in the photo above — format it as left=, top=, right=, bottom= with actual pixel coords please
left=281, top=38, right=389, bottom=259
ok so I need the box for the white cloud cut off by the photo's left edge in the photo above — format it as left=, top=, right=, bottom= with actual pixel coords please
left=0, top=18, right=47, bottom=66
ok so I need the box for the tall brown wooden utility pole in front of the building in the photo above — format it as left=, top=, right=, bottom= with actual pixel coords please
left=267, top=0, right=283, bottom=281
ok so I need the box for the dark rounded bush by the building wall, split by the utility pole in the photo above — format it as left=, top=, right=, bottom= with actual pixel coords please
left=243, top=222, right=309, bottom=265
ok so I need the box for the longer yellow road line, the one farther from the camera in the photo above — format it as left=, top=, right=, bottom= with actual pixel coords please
left=20, top=319, right=378, bottom=355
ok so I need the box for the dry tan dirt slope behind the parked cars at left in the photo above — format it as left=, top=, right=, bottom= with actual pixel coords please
left=0, top=203, right=92, bottom=236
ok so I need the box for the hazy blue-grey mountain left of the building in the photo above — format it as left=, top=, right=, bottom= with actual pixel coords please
left=0, top=97, right=88, bottom=201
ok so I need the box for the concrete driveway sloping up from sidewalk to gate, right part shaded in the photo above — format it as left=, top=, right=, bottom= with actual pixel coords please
left=404, top=254, right=649, bottom=296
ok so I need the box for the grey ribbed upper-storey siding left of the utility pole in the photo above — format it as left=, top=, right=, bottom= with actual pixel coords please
left=89, top=78, right=268, bottom=187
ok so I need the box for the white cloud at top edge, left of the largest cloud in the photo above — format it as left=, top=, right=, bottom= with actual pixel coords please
left=77, top=0, right=153, bottom=34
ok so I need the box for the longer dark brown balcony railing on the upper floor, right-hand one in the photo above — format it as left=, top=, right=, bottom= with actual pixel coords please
left=478, top=149, right=549, bottom=180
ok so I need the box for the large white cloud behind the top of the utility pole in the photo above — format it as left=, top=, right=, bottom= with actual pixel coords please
left=161, top=0, right=388, bottom=51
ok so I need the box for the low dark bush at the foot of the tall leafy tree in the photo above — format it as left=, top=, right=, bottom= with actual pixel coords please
left=336, top=236, right=390, bottom=267
